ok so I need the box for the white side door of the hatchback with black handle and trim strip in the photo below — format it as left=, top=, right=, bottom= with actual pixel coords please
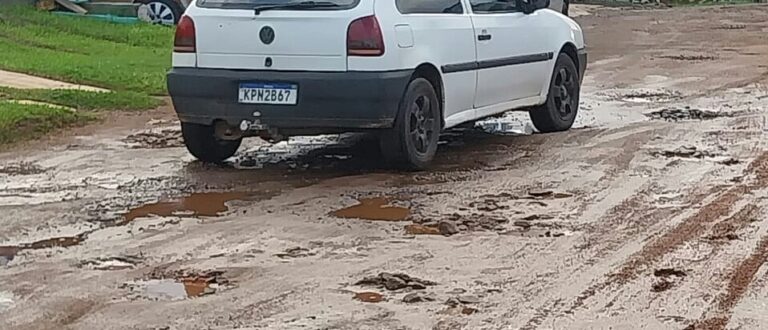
left=470, top=0, right=554, bottom=108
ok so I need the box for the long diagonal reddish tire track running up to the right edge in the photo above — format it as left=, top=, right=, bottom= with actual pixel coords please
left=566, top=152, right=768, bottom=314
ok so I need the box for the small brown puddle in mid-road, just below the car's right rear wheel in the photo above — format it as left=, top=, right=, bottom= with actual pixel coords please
left=331, top=197, right=411, bottom=221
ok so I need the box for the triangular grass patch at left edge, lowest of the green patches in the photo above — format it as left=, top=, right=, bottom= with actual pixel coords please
left=0, top=101, right=96, bottom=144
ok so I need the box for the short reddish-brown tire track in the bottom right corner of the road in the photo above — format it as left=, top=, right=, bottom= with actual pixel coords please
left=685, top=235, right=768, bottom=330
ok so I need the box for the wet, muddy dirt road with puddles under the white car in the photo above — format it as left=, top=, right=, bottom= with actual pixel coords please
left=0, top=6, right=768, bottom=329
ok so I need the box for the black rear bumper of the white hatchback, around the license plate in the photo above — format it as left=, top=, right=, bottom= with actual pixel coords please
left=168, top=68, right=413, bottom=131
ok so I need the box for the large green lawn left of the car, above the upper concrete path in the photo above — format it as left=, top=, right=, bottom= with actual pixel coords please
left=0, top=6, right=174, bottom=95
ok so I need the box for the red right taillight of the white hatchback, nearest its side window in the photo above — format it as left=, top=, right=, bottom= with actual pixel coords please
left=347, top=16, right=384, bottom=56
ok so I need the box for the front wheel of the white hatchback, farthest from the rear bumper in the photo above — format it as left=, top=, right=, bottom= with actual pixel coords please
left=529, top=53, right=581, bottom=133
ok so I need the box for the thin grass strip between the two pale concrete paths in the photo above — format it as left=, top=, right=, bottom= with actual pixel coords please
left=0, top=87, right=162, bottom=111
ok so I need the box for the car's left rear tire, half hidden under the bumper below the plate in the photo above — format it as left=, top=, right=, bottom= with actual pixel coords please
left=181, top=123, right=242, bottom=164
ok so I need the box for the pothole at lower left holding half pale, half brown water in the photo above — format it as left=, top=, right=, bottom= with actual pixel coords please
left=120, top=270, right=233, bottom=301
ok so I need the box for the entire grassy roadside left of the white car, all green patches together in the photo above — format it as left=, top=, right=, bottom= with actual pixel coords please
left=0, top=5, right=174, bottom=144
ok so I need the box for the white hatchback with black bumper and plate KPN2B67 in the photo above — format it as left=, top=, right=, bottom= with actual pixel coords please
left=168, top=0, right=587, bottom=169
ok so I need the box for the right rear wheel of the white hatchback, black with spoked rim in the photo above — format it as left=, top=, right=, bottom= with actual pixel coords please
left=379, top=78, right=442, bottom=170
